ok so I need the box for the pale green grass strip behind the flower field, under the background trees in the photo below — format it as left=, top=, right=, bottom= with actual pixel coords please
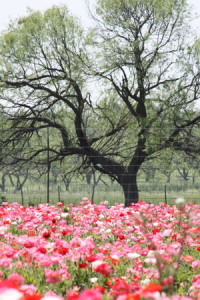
left=0, top=174, right=200, bottom=205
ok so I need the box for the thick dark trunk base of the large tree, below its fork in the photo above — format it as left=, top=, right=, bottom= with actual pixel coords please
left=119, top=174, right=139, bottom=207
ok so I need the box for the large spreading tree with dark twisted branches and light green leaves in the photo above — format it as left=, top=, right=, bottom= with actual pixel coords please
left=0, top=0, right=200, bottom=206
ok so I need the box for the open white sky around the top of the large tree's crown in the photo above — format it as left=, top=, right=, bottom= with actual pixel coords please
left=0, top=0, right=200, bottom=31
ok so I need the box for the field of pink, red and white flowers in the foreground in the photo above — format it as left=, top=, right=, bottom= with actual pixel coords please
left=0, top=198, right=200, bottom=300
